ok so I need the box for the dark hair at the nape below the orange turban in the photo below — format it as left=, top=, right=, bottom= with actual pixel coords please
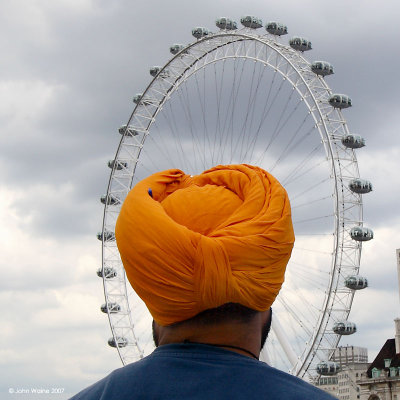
left=170, top=303, right=258, bottom=327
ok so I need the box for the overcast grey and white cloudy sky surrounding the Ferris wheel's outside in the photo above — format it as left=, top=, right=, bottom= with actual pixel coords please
left=0, top=0, right=400, bottom=400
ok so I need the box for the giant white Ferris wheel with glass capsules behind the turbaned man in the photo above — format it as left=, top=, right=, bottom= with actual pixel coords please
left=97, top=16, right=373, bottom=379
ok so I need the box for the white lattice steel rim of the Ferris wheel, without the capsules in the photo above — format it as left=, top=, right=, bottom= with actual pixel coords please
left=99, top=29, right=362, bottom=376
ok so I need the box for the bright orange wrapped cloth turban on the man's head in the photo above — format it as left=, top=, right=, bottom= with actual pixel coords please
left=115, top=165, right=294, bottom=325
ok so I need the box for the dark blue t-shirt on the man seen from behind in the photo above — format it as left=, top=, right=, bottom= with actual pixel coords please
left=72, top=343, right=334, bottom=400
